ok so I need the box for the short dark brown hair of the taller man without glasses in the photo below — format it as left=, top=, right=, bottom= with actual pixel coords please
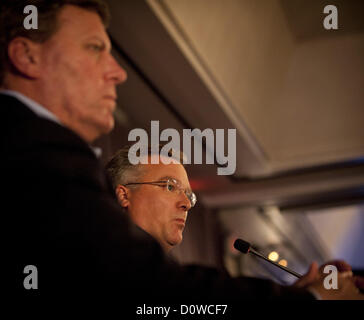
left=0, top=0, right=110, bottom=86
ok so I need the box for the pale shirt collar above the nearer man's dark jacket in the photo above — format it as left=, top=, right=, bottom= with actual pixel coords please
left=0, top=89, right=102, bottom=158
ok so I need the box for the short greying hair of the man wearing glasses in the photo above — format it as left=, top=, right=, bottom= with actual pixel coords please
left=106, top=144, right=184, bottom=190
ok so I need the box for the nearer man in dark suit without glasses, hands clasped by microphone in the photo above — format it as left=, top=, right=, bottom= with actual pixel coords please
left=0, top=0, right=357, bottom=301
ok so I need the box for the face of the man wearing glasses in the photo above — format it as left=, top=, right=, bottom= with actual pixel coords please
left=117, top=158, right=191, bottom=251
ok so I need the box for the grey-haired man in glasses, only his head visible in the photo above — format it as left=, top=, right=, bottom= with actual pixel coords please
left=107, top=147, right=197, bottom=252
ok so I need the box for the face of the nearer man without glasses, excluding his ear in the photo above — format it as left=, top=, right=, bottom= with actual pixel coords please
left=40, top=5, right=126, bottom=141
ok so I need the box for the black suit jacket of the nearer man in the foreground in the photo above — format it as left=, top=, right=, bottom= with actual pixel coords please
left=0, top=94, right=312, bottom=302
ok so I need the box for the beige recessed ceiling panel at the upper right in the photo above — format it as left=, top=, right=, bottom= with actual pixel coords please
left=148, top=0, right=364, bottom=176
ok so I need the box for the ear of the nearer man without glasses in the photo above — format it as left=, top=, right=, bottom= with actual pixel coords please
left=8, top=37, right=41, bottom=79
